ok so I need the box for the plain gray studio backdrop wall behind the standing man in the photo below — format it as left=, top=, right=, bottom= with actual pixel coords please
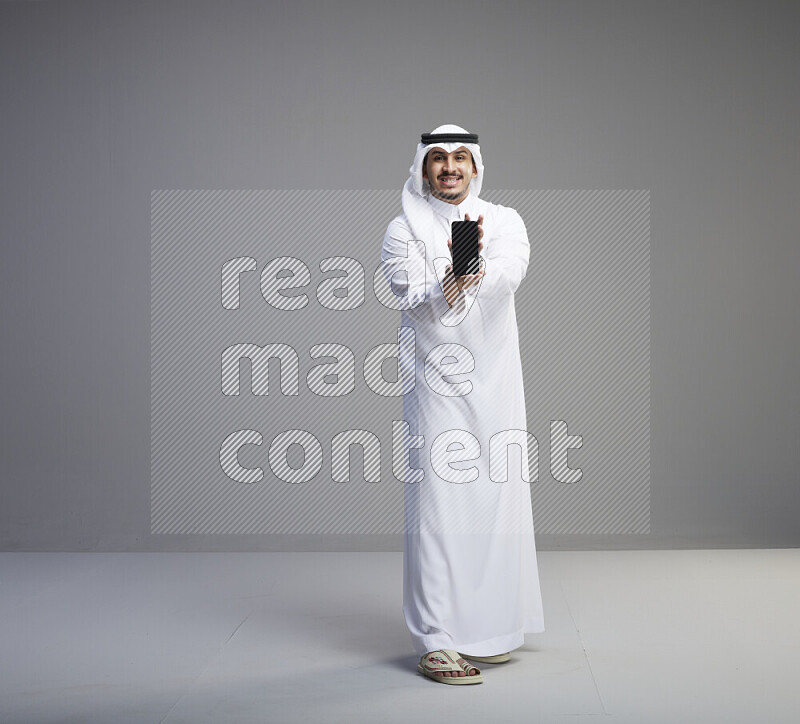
left=0, top=0, right=800, bottom=550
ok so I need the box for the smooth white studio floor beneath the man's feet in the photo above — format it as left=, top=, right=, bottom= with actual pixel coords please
left=0, top=549, right=800, bottom=724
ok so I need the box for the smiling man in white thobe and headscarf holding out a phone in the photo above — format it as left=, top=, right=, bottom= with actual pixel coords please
left=381, top=125, right=544, bottom=684
